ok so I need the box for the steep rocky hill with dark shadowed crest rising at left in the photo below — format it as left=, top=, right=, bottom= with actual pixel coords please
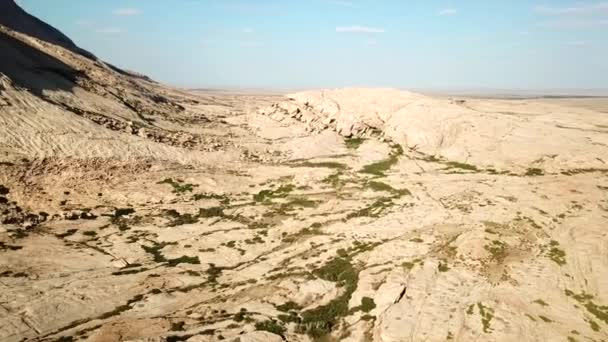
left=0, top=0, right=256, bottom=161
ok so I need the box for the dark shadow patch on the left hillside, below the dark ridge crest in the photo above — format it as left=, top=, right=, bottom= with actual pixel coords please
left=0, top=32, right=81, bottom=96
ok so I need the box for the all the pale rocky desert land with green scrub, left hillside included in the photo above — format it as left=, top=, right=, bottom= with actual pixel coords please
left=0, top=1, right=608, bottom=342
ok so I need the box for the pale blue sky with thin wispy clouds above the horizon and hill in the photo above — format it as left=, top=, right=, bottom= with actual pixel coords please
left=18, top=0, right=608, bottom=89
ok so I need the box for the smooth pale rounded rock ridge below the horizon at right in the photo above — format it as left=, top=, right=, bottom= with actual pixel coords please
left=260, top=88, right=608, bottom=171
